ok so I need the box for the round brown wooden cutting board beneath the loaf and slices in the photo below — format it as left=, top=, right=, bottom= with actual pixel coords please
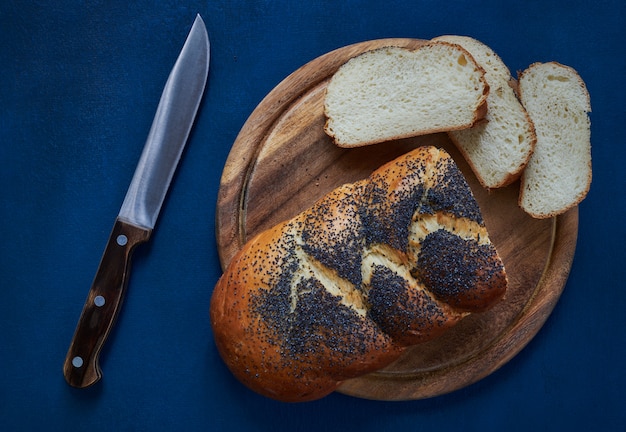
left=216, top=39, right=578, bottom=400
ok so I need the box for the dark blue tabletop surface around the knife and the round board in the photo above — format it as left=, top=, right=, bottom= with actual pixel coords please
left=0, top=0, right=626, bottom=431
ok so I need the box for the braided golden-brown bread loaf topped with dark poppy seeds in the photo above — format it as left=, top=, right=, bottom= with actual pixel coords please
left=210, top=147, right=507, bottom=402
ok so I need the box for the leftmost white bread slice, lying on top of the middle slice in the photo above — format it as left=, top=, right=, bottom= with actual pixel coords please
left=324, top=42, right=489, bottom=147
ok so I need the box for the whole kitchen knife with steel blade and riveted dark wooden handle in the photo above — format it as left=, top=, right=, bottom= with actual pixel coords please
left=63, top=15, right=210, bottom=388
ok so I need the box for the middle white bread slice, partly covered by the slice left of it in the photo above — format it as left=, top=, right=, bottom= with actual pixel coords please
left=434, top=35, right=537, bottom=188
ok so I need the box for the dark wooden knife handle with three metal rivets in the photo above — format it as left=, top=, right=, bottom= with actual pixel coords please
left=63, top=218, right=152, bottom=388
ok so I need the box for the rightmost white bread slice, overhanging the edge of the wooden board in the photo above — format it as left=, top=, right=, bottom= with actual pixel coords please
left=519, top=62, right=591, bottom=218
